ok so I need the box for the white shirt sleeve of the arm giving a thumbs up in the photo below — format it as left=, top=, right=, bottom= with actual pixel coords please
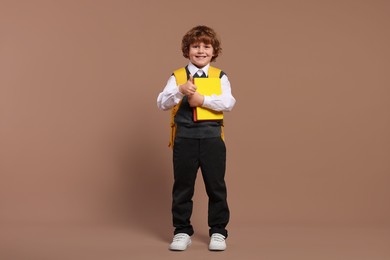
left=157, top=75, right=184, bottom=110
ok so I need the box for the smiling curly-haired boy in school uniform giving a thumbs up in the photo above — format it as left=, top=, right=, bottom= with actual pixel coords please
left=157, top=26, right=236, bottom=251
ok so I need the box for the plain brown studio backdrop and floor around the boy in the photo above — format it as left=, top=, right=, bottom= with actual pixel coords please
left=0, top=0, right=390, bottom=259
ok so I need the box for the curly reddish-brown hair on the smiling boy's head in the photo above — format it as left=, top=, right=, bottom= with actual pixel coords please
left=181, top=25, right=222, bottom=61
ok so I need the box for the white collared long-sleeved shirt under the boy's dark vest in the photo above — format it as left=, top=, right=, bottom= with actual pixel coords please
left=157, top=62, right=236, bottom=111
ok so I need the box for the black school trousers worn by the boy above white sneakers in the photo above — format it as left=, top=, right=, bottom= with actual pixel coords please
left=172, top=137, right=230, bottom=237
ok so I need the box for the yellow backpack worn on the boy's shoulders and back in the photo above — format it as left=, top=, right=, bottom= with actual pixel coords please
left=168, top=66, right=224, bottom=148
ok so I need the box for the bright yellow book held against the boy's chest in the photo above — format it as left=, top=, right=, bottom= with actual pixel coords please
left=194, top=78, right=223, bottom=122
